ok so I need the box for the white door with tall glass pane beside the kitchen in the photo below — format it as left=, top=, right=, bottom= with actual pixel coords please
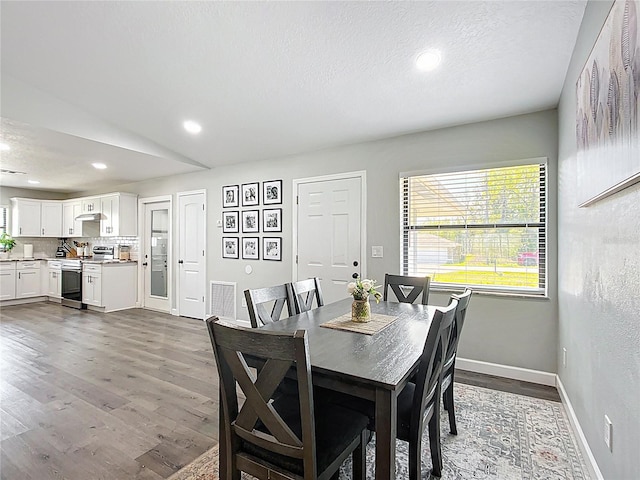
left=142, top=201, right=171, bottom=313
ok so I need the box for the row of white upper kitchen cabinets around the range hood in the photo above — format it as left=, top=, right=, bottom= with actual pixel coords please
left=11, top=193, right=138, bottom=238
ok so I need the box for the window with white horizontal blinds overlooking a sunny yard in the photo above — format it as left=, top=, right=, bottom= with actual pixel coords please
left=400, top=164, right=546, bottom=295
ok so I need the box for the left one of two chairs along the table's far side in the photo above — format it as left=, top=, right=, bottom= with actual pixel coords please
left=244, top=283, right=294, bottom=328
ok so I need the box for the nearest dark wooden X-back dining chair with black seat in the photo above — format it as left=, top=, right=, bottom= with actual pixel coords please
left=207, top=317, right=369, bottom=480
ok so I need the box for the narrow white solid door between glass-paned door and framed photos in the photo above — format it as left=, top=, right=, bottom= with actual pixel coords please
left=178, top=191, right=207, bottom=319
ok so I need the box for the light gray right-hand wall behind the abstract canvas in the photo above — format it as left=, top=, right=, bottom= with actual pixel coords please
left=558, top=1, right=640, bottom=480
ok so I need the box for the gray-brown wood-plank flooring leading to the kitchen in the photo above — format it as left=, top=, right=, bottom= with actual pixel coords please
left=0, top=303, right=560, bottom=480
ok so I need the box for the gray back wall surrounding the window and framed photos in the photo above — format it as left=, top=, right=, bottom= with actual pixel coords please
left=106, top=110, right=558, bottom=373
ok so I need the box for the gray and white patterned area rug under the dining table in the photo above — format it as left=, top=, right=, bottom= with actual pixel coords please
left=170, top=383, right=590, bottom=480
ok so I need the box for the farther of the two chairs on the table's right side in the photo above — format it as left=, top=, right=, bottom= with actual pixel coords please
left=442, top=288, right=473, bottom=435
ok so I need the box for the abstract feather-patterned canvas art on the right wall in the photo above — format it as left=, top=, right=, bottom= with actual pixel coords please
left=576, top=0, right=640, bottom=206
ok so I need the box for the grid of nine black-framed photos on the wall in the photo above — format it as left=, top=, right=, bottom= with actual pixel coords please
left=222, top=180, right=282, bottom=261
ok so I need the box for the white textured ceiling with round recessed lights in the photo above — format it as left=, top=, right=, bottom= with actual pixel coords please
left=0, top=1, right=585, bottom=193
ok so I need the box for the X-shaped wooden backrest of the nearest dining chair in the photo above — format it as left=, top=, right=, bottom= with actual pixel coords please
left=207, top=317, right=315, bottom=462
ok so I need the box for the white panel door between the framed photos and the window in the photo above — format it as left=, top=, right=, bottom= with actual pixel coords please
left=295, top=174, right=365, bottom=303
